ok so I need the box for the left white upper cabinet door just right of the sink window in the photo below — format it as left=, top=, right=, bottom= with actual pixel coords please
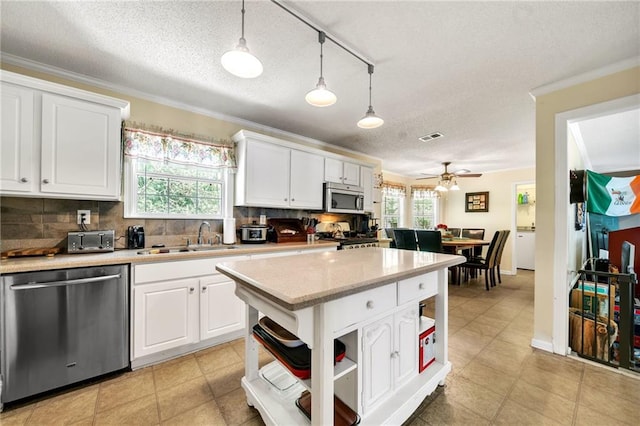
left=245, top=140, right=290, bottom=207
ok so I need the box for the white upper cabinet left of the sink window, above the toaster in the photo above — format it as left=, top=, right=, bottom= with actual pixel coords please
left=0, top=71, right=129, bottom=200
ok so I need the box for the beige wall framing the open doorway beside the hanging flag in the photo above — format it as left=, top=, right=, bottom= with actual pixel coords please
left=533, top=66, right=640, bottom=350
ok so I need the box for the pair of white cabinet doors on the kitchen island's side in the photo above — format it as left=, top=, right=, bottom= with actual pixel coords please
left=362, top=307, right=419, bottom=413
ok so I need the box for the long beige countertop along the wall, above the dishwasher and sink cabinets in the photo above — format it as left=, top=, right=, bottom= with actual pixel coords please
left=0, top=241, right=338, bottom=274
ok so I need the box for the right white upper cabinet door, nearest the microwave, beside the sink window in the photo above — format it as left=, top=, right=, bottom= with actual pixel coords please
left=289, top=149, right=324, bottom=210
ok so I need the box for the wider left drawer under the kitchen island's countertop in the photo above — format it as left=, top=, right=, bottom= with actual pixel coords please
left=327, top=283, right=396, bottom=330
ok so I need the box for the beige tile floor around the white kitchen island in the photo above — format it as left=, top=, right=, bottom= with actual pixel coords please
left=0, top=271, right=640, bottom=426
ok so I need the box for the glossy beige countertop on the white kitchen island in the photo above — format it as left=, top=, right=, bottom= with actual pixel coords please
left=216, top=247, right=465, bottom=310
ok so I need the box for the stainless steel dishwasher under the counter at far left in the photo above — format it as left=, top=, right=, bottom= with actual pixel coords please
left=0, top=265, right=129, bottom=410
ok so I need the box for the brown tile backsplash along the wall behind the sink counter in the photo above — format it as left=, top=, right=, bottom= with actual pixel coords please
left=0, top=197, right=330, bottom=251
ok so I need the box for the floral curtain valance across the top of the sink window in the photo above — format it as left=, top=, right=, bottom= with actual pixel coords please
left=123, top=123, right=236, bottom=168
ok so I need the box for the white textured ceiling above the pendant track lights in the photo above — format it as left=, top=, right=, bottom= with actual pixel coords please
left=0, top=0, right=640, bottom=176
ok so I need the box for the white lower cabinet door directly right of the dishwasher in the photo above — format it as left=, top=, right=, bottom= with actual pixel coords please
left=133, top=278, right=198, bottom=358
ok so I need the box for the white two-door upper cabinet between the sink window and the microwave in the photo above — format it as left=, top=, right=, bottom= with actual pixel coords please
left=233, top=130, right=324, bottom=210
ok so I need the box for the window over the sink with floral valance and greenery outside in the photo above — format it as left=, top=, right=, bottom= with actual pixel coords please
left=124, top=122, right=235, bottom=219
